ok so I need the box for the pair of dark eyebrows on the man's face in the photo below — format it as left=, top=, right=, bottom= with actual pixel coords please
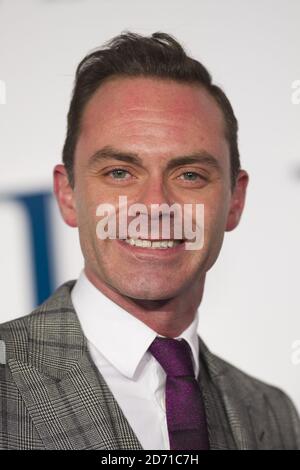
left=88, top=146, right=221, bottom=172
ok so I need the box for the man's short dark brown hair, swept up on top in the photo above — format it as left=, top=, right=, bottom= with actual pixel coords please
left=63, top=32, right=240, bottom=187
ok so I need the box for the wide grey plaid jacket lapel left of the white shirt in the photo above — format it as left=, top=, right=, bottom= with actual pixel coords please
left=8, top=282, right=142, bottom=449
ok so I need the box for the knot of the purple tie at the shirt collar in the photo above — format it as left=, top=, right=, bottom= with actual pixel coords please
left=149, top=337, right=194, bottom=377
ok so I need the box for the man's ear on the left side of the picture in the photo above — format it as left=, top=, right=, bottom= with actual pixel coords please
left=53, top=165, right=77, bottom=227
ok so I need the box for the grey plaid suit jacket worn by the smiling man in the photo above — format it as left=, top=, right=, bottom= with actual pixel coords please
left=0, top=281, right=300, bottom=450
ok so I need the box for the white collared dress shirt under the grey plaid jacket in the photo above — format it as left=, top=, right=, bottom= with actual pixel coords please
left=71, top=271, right=199, bottom=450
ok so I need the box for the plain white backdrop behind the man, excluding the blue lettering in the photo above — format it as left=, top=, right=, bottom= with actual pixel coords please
left=0, top=0, right=300, bottom=409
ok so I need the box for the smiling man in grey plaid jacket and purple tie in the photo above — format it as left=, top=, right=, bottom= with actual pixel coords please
left=0, top=33, right=300, bottom=450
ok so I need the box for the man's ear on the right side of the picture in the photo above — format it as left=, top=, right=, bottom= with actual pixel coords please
left=225, top=170, right=249, bottom=232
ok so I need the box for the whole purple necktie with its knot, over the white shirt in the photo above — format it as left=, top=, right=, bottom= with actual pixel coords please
left=149, top=337, right=209, bottom=450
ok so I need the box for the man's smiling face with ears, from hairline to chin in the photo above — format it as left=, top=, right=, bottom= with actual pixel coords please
left=56, top=78, right=246, bottom=300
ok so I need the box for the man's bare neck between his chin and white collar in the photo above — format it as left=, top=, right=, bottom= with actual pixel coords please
left=85, top=267, right=205, bottom=338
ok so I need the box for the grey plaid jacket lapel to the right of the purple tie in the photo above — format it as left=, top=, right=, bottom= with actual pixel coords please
left=199, top=338, right=265, bottom=450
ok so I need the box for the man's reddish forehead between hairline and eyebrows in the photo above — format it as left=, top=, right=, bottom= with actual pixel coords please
left=77, top=77, right=227, bottom=163
